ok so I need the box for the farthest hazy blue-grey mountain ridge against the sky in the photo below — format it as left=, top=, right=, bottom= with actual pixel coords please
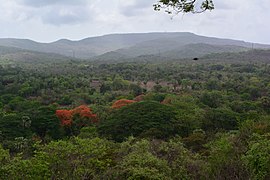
left=0, top=32, right=270, bottom=59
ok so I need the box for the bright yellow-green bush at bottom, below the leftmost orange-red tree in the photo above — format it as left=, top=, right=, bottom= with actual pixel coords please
left=40, top=138, right=113, bottom=179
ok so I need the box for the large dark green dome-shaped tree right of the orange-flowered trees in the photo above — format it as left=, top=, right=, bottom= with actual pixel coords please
left=99, top=101, right=175, bottom=141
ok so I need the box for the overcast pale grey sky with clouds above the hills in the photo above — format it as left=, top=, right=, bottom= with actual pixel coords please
left=0, top=0, right=270, bottom=44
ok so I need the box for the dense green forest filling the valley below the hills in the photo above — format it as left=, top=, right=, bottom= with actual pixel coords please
left=0, top=54, right=270, bottom=180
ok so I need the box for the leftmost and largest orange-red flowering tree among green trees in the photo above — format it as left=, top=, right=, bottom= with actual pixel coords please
left=55, top=105, right=98, bottom=135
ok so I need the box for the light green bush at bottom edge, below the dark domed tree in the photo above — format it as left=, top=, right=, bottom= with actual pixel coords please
left=114, top=138, right=171, bottom=180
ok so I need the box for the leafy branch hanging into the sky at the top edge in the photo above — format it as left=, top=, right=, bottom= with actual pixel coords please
left=154, top=0, right=214, bottom=14
